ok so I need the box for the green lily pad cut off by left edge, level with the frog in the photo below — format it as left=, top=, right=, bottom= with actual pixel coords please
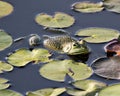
left=0, top=29, right=13, bottom=51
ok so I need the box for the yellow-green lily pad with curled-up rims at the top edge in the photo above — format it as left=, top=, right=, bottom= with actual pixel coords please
left=72, top=1, right=104, bottom=13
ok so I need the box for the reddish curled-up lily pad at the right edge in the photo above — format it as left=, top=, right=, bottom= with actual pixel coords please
left=104, top=39, right=120, bottom=56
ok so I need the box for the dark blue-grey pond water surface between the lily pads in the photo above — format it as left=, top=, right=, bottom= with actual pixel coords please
left=0, top=0, right=120, bottom=96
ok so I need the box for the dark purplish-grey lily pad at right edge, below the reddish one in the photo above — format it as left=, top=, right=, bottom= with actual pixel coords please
left=91, top=56, right=120, bottom=79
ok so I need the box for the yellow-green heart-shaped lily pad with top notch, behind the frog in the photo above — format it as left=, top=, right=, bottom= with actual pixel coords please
left=35, top=12, right=75, bottom=28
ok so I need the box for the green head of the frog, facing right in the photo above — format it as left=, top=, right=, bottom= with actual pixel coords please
left=68, top=40, right=90, bottom=55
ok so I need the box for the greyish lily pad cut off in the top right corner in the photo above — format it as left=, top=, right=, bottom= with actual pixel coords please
left=103, top=0, right=120, bottom=13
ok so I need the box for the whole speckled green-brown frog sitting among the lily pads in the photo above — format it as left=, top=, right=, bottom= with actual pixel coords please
left=43, top=35, right=89, bottom=55
